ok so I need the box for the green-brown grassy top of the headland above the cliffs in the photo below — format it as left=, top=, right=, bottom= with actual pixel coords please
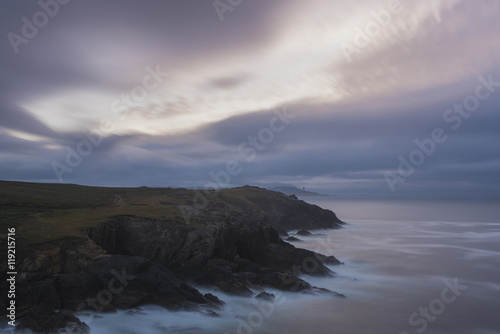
left=0, top=181, right=288, bottom=248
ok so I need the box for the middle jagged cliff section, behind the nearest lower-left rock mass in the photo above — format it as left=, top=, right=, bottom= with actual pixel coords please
left=89, top=206, right=340, bottom=296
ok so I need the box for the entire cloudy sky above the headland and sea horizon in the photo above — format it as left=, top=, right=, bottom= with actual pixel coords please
left=0, top=0, right=500, bottom=198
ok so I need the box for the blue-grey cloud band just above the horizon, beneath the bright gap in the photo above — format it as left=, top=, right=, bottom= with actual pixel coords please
left=2, top=84, right=500, bottom=193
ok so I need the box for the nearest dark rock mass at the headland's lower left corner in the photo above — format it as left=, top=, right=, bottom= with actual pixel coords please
left=0, top=238, right=223, bottom=333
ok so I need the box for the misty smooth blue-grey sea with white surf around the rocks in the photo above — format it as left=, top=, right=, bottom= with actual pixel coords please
left=3, top=197, right=500, bottom=334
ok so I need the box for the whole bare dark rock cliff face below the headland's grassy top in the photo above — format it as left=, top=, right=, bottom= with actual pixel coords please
left=5, top=190, right=340, bottom=333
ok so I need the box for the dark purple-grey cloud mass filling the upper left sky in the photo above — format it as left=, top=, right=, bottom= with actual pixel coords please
left=0, top=0, right=278, bottom=89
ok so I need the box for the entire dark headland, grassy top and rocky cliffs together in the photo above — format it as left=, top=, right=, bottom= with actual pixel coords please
left=0, top=181, right=342, bottom=329
